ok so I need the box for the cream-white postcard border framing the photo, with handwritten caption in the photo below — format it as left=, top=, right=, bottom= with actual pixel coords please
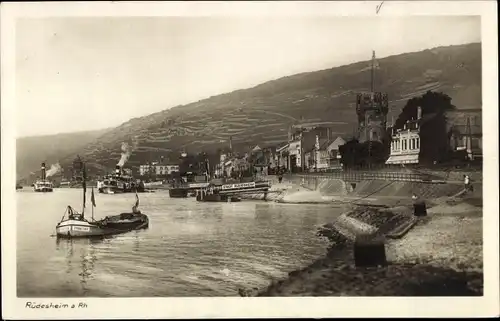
left=1, top=1, right=499, bottom=319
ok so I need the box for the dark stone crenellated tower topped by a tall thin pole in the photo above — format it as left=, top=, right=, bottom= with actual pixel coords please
left=356, top=51, right=389, bottom=143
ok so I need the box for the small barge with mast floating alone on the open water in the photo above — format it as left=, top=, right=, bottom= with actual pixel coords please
left=56, top=158, right=149, bottom=238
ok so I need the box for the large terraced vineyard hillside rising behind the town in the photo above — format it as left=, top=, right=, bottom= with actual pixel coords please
left=18, top=43, right=481, bottom=178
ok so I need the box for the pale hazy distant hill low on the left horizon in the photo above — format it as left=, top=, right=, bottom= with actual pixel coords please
left=16, top=130, right=106, bottom=179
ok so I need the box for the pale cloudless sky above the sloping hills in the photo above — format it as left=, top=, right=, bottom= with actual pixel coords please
left=16, top=16, right=481, bottom=137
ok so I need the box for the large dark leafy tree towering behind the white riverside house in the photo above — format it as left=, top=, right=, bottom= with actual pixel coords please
left=394, top=91, right=456, bottom=164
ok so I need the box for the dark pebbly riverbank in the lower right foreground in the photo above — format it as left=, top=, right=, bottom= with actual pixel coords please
left=240, top=192, right=483, bottom=296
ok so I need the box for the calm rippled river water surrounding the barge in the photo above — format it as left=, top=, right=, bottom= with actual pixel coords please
left=17, top=188, right=341, bottom=297
